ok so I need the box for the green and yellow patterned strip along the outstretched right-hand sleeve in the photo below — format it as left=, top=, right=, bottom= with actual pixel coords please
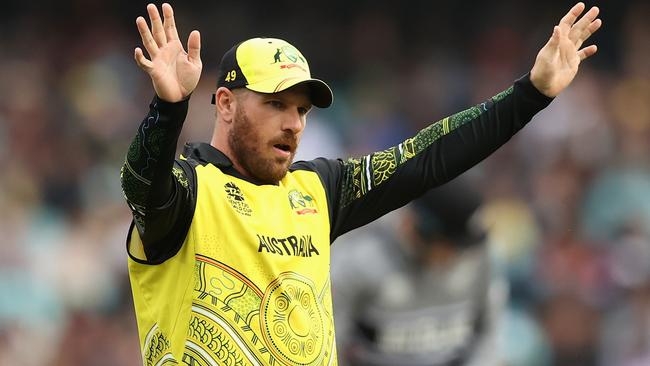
left=341, top=86, right=513, bottom=207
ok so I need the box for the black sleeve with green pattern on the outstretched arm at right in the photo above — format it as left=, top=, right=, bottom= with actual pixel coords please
left=309, top=74, right=552, bottom=241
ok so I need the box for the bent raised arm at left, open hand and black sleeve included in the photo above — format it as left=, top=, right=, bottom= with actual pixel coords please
left=121, top=4, right=201, bottom=262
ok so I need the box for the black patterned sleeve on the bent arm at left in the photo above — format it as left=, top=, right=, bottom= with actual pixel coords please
left=121, top=96, right=194, bottom=263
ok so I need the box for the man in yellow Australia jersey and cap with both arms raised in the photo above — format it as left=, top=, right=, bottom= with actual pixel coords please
left=122, top=3, right=601, bottom=365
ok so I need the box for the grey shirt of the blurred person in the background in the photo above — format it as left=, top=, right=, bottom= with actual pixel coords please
left=332, top=219, right=496, bottom=366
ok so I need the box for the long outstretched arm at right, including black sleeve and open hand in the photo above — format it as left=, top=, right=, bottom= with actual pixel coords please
left=313, top=3, right=601, bottom=240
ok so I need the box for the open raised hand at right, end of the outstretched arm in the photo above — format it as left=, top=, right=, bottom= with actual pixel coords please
left=530, top=3, right=602, bottom=97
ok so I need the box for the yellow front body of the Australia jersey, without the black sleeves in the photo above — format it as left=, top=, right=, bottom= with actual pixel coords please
left=129, top=164, right=337, bottom=366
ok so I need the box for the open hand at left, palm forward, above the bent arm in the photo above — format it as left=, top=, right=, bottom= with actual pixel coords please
left=135, top=3, right=203, bottom=102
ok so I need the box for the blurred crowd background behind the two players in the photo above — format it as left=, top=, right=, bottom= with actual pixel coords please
left=0, top=0, right=650, bottom=366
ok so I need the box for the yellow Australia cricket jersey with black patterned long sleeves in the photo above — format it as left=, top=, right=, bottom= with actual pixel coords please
left=121, top=76, right=551, bottom=366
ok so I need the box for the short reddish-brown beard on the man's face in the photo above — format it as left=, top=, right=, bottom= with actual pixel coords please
left=228, top=108, right=294, bottom=184
